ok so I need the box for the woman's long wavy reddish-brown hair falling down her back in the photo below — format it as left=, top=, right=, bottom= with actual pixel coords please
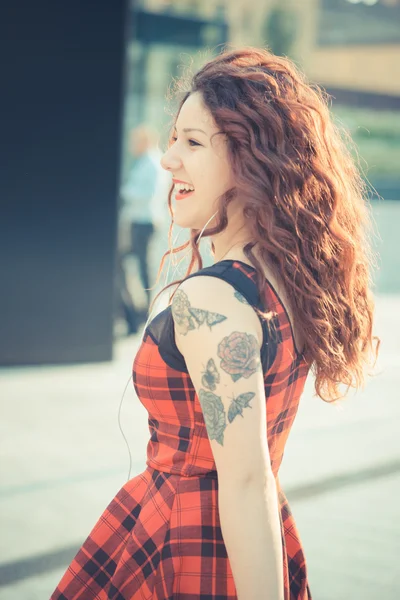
left=153, top=47, right=380, bottom=402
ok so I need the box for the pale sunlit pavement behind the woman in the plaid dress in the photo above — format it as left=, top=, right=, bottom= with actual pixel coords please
left=0, top=296, right=400, bottom=600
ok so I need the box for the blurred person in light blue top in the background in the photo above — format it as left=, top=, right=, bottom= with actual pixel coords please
left=119, top=123, right=163, bottom=334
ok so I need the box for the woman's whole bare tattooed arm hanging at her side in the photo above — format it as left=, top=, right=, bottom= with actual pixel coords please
left=172, top=276, right=284, bottom=600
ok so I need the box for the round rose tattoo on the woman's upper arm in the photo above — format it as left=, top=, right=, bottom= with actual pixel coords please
left=218, top=331, right=261, bottom=381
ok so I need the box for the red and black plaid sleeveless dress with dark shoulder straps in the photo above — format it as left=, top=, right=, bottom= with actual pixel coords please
left=51, top=260, right=311, bottom=600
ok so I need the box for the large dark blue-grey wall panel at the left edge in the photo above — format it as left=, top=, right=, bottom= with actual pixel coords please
left=0, top=0, right=126, bottom=366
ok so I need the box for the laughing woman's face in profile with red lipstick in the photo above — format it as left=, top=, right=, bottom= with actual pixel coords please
left=161, top=92, right=234, bottom=229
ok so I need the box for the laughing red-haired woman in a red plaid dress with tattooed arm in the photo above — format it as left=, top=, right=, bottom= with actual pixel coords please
left=52, top=48, right=379, bottom=600
